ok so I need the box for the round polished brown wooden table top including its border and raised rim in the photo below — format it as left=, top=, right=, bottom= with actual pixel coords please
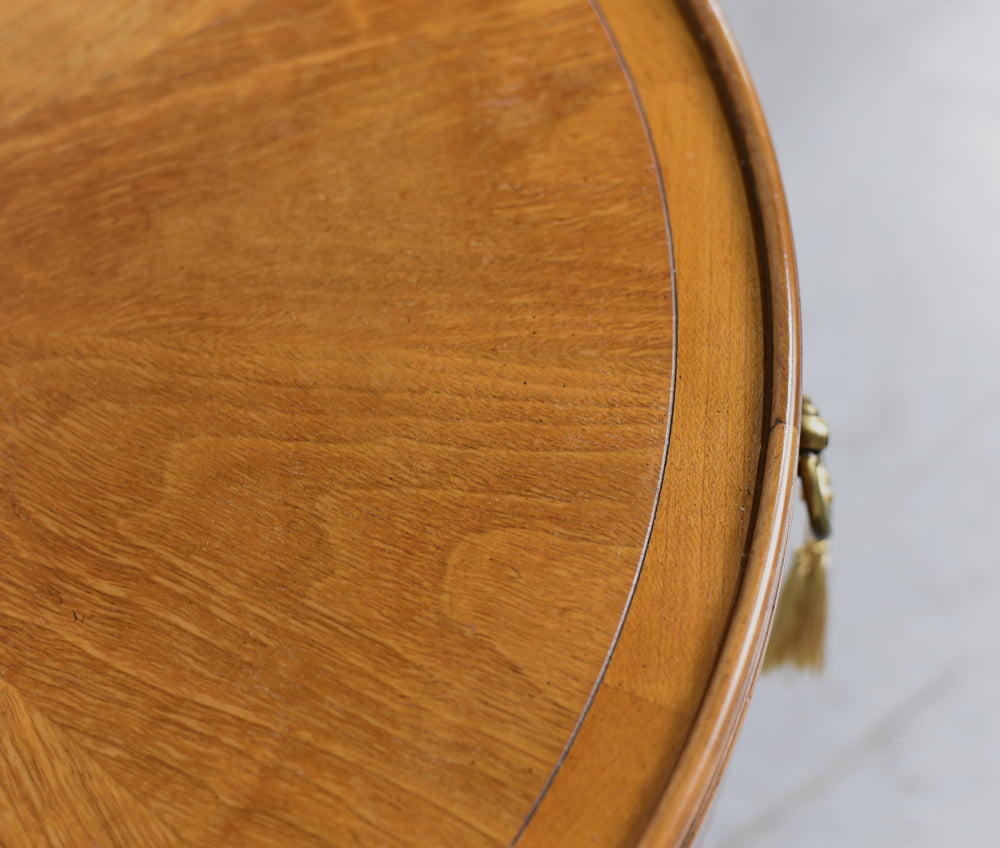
left=0, top=0, right=799, bottom=848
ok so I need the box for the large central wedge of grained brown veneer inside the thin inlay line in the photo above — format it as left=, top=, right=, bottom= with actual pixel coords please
left=0, top=2, right=672, bottom=845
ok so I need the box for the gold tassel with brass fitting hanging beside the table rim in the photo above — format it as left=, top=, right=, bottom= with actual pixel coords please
left=763, top=397, right=833, bottom=673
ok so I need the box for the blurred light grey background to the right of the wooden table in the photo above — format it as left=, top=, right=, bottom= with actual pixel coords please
left=702, top=0, right=1000, bottom=848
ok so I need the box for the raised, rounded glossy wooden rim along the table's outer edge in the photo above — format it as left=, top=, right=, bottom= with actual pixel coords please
left=637, top=0, right=801, bottom=848
